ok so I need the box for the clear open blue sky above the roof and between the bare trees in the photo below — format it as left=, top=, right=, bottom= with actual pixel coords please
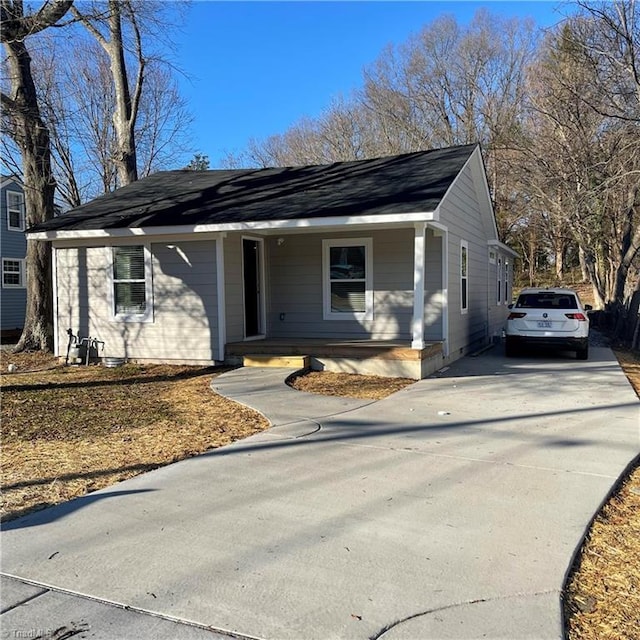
left=174, top=0, right=562, bottom=168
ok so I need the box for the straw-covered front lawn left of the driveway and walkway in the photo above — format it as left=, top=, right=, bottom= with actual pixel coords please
left=0, top=352, right=268, bottom=520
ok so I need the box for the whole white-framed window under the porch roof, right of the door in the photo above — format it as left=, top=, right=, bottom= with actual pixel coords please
left=322, top=238, right=373, bottom=320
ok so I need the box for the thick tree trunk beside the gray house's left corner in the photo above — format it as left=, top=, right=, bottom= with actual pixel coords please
left=5, top=40, right=56, bottom=351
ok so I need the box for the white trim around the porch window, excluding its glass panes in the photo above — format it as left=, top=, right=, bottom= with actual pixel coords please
left=322, top=238, right=373, bottom=321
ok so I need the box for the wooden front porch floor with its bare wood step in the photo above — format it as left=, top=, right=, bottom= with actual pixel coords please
left=225, top=338, right=442, bottom=361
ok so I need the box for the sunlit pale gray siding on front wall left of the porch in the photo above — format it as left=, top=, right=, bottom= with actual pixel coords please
left=56, top=240, right=219, bottom=362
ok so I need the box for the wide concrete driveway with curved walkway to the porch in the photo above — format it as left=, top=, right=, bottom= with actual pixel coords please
left=0, top=348, right=640, bottom=640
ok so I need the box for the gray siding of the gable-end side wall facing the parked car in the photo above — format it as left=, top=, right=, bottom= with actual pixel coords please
left=440, top=161, right=491, bottom=357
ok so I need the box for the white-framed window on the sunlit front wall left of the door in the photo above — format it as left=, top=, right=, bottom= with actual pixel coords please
left=107, top=244, right=153, bottom=322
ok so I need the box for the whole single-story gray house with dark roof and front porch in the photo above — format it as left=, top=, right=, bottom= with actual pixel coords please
left=30, top=145, right=516, bottom=378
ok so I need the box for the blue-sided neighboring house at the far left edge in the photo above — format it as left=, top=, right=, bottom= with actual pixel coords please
left=0, top=176, right=27, bottom=337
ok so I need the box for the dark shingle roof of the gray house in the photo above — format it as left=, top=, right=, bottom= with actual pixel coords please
left=30, top=145, right=476, bottom=231
